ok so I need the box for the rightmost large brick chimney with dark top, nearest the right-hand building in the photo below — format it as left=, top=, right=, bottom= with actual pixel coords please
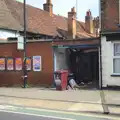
left=85, top=10, right=94, bottom=34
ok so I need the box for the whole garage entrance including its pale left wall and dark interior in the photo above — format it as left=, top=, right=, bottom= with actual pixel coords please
left=54, top=45, right=99, bottom=89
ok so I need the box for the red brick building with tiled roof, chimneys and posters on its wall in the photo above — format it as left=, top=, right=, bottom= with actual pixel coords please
left=0, top=0, right=99, bottom=86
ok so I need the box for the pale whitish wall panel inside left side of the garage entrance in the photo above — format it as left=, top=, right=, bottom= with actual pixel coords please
left=54, top=48, right=68, bottom=71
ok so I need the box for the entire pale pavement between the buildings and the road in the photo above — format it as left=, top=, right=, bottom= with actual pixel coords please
left=0, top=88, right=120, bottom=115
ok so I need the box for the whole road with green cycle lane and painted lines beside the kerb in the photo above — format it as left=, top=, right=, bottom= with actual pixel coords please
left=0, top=105, right=119, bottom=120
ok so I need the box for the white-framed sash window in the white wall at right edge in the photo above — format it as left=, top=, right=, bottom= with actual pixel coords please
left=113, top=43, right=120, bottom=74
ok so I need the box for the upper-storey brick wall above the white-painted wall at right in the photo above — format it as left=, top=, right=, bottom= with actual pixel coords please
left=101, top=0, right=119, bottom=31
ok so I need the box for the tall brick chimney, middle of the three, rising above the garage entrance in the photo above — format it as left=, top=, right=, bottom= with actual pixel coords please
left=68, top=7, right=76, bottom=39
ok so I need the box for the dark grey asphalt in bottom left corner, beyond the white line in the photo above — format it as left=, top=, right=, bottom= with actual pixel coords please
left=0, top=112, right=65, bottom=120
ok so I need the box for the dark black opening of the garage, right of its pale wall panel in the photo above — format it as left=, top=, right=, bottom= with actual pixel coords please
left=67, top=48, right=99, bottom=88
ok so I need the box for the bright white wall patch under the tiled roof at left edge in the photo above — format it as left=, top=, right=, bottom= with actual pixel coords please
left=0, top=29, right=19, bottom=39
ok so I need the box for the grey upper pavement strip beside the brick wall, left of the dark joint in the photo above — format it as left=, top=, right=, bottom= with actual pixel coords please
left=0, top=88, right=101, bottom=103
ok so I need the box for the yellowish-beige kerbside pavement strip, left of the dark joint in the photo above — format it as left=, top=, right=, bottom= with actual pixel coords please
left=0, top=97, right=103, bottom=113
